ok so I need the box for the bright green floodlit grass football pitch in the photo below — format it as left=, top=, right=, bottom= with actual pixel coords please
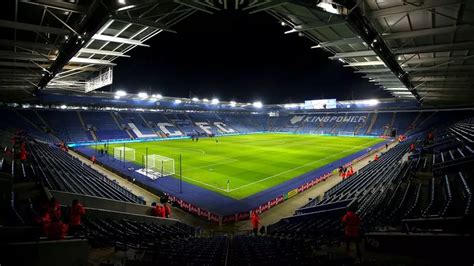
left=98, top=134, right=383, bottom=199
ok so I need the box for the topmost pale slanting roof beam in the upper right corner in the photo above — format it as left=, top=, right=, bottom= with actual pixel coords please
left=368, top=0, right=462, bottom=18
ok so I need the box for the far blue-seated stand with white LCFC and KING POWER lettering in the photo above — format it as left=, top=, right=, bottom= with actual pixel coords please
left=2, top=109, right=458, bottom=142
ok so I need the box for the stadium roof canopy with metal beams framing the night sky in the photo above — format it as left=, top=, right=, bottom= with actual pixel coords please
left=0, top=0, right=474, bottom=104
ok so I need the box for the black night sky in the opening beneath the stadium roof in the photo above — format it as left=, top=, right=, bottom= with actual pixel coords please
left=112, top=11, right=387, bottom=103
